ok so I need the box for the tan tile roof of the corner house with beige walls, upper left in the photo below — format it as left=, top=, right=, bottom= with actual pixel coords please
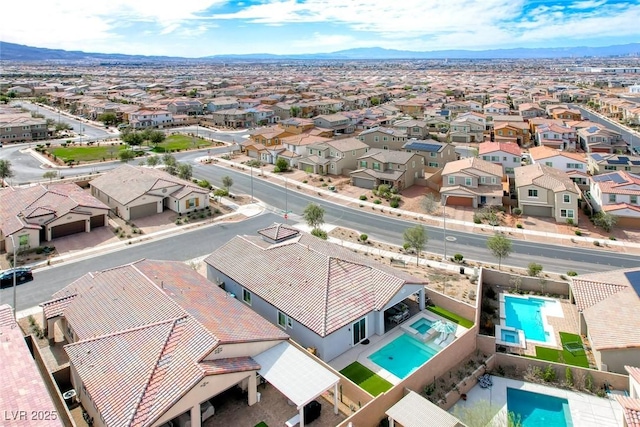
left=91, top=164, right=208, bottom=204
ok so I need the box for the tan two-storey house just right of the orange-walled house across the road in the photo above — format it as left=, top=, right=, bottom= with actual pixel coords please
left=297, top=138, right=369, bottom=175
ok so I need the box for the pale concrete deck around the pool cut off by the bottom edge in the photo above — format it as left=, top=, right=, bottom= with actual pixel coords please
left=450, top=376, right=623, bottom=427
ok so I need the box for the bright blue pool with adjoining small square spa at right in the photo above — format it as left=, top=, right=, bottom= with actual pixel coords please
left=504, top=296, right=548, bottom=342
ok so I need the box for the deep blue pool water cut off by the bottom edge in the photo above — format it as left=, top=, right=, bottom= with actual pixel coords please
left=507, top=387, right=573, bottom=427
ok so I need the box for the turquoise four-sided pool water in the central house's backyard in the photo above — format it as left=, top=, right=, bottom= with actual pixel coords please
left=369, top=334, right=438, bottom=379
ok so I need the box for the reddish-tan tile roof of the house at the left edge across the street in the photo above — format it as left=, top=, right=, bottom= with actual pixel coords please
left=0, top=184, right=109, bottom=236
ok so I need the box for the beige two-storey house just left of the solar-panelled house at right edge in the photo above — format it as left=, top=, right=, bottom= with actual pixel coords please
left=515, top=163, right=581, bottom=224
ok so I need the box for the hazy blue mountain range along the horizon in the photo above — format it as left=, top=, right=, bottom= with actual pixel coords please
left=0, top=42, right=640, bottom=61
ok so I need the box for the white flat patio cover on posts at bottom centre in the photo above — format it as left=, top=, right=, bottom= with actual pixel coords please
left=254, top=342, right=340, bottom=427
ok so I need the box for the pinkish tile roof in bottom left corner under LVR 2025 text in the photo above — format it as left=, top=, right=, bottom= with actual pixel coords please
left=0, top=304, right=63, bottom=427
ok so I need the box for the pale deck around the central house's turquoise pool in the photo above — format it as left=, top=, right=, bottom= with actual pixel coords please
left=329, top=310, right=466, bottom=385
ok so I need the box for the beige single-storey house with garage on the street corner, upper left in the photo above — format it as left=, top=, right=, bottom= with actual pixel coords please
left=89, top=164, right=209, bottom=221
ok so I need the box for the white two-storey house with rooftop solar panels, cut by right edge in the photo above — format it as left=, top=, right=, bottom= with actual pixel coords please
left=589, top=171, right=640, bottom=228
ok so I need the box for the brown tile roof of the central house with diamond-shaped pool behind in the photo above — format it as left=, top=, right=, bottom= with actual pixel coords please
left=205, top=233, right=424, bottom=336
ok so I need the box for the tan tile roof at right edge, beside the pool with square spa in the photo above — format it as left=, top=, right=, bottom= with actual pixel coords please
left=571, top=268, right=640, bottom=350
